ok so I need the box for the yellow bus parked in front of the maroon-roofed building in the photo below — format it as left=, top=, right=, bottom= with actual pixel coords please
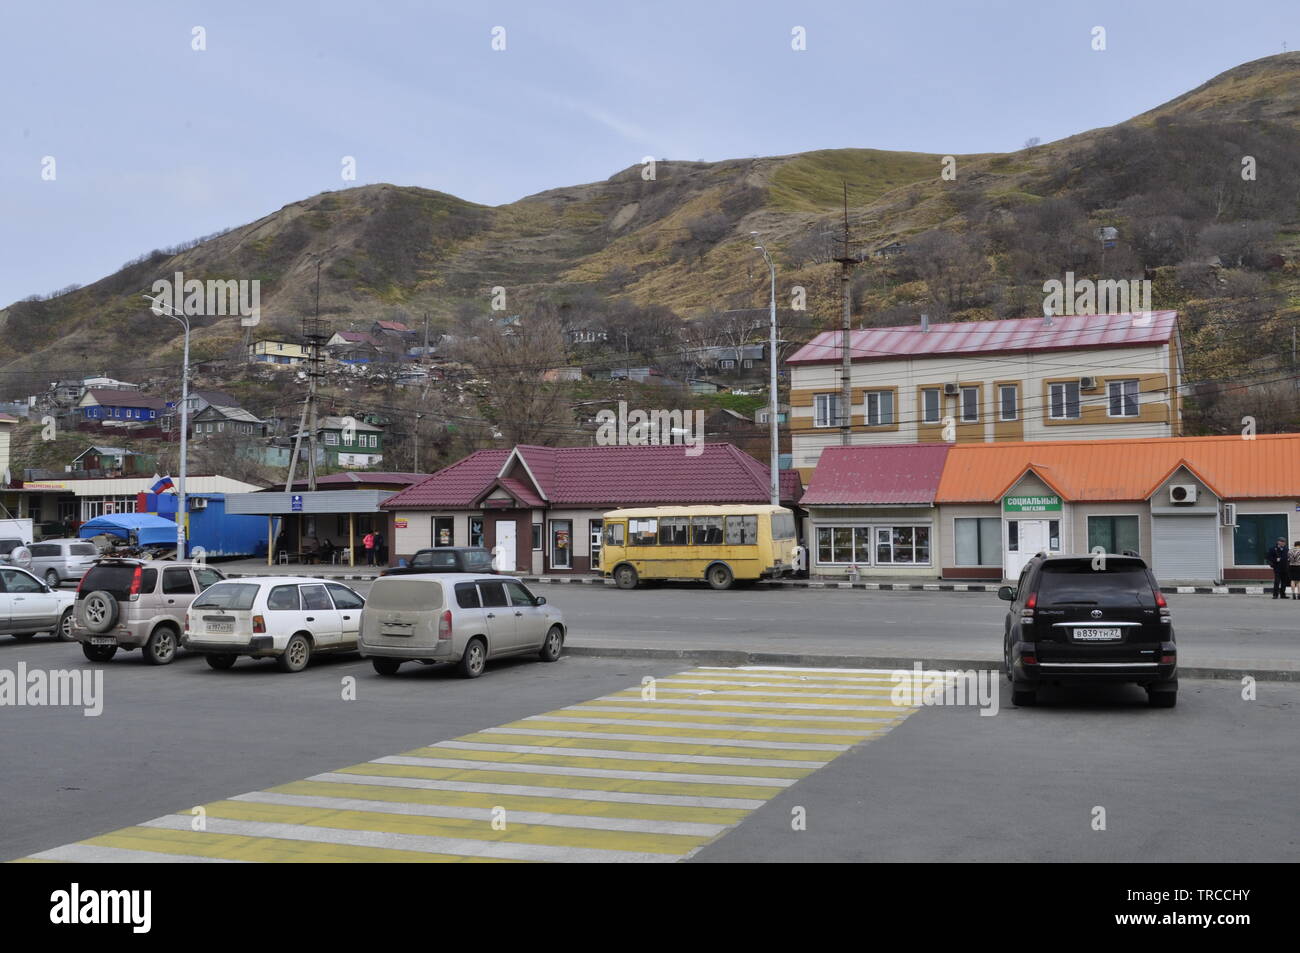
left=601, top=506, right=798, bottom=589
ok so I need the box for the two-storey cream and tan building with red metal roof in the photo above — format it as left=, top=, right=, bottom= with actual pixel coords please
left=787, top=311, right=1183, bottom=472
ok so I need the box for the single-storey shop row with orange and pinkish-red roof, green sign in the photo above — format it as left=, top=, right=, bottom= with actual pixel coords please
left=802, top=434, right=1300, bottom=584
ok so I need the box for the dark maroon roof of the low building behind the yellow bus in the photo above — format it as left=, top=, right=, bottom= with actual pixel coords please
left=384, top=443, right=802, bottom=510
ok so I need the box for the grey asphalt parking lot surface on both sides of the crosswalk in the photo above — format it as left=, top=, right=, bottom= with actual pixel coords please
left=0, top=631, right=1300, bottom=862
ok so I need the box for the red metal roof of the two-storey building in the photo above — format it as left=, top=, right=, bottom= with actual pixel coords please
left=785, top=311, right=1178, bottom=364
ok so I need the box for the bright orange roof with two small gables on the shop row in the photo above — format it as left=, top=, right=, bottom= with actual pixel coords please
left=935, top=433, right=1300, bottom=503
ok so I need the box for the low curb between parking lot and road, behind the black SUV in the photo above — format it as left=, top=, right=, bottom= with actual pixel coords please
left=564, top=644, right=1300, bottom=681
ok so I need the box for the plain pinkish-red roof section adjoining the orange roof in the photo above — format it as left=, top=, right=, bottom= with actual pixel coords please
left=800, top=443, right=952, bottom=506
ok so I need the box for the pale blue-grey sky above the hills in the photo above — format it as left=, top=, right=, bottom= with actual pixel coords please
left=0, top=0, right=1300, bottom=307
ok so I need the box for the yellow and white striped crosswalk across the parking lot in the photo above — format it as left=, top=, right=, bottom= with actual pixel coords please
left=17, top=666, right=915, bottom=863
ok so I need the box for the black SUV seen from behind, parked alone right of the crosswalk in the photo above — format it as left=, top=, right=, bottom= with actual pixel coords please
left=997, top=553, right=1178, bottom=709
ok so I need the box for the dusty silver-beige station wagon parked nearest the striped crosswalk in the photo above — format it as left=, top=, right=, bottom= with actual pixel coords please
left=356, top=572, right=567, bottom=679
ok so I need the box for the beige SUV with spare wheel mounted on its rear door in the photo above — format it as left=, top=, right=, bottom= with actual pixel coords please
left=73, top=558, right=225, bottom=666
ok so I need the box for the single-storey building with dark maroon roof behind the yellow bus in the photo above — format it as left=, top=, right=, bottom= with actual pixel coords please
left=382, top=443, right=803, bottom=573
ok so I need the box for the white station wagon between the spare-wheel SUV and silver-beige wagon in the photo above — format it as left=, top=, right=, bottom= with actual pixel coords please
left=182, top=576, right=365, bottom=672
